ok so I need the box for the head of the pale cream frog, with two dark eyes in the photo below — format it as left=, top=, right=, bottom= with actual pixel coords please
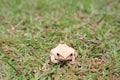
left=51, top=44, right=77, bottom=61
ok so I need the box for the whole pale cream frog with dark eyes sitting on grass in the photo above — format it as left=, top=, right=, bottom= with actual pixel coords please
left=50, top=42, right=78, bottom=63
